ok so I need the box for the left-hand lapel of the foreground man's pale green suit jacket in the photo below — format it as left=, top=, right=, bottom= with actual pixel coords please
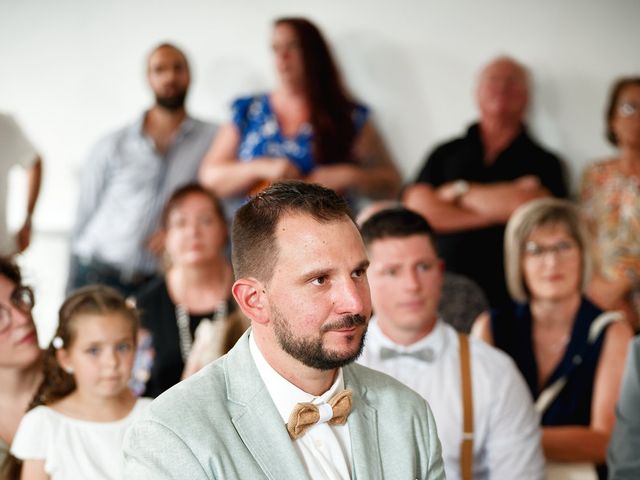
left=224, top=331, right=309, bottom=480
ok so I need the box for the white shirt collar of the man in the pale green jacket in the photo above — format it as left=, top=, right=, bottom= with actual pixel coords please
left=249, top=335, right=344, bottom=423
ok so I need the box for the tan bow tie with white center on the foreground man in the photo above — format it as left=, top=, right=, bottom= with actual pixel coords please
left=287, top=390, right=351, bottom=440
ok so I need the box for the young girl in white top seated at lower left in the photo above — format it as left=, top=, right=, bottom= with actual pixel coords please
left=11, top=286, right=149, bottom=480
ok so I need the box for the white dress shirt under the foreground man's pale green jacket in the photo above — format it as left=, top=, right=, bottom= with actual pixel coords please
left=249, top=335, right=353, bottom=480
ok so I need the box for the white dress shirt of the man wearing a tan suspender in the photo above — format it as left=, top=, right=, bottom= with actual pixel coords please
left=358, top=319, right=544, bottom=480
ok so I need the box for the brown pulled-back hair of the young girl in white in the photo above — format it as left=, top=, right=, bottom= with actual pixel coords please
left=29, top=286, right=138, bottom=408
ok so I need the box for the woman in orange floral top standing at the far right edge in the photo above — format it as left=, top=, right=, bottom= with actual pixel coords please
left=581, top=77, right=640, bottom=331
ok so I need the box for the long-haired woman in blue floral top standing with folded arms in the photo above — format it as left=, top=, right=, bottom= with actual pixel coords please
left=200, top=18, right=400, bottom=218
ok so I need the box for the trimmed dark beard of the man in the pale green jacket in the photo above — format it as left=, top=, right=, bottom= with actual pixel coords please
left=273, top=309, right=367, bottom=370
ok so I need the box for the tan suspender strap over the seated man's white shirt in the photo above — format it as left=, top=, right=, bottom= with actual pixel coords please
left=458, top=332, right=473, bottom=480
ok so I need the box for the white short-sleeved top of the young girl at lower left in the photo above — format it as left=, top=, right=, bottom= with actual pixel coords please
left=11, top=398, right=151, bottom=480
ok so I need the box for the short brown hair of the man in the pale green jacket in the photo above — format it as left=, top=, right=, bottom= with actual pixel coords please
left=231, top=181, right=353, bottom=282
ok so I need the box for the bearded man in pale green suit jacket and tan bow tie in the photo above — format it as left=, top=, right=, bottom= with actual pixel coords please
left=124, top=182, right=444, bottom=480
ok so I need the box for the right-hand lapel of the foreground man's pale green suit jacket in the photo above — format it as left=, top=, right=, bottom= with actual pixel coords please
left=343, top=366, right=382, bottom=480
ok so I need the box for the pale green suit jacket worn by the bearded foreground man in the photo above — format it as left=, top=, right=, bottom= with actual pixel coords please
left=124, top=332, right=444, bottom=480
